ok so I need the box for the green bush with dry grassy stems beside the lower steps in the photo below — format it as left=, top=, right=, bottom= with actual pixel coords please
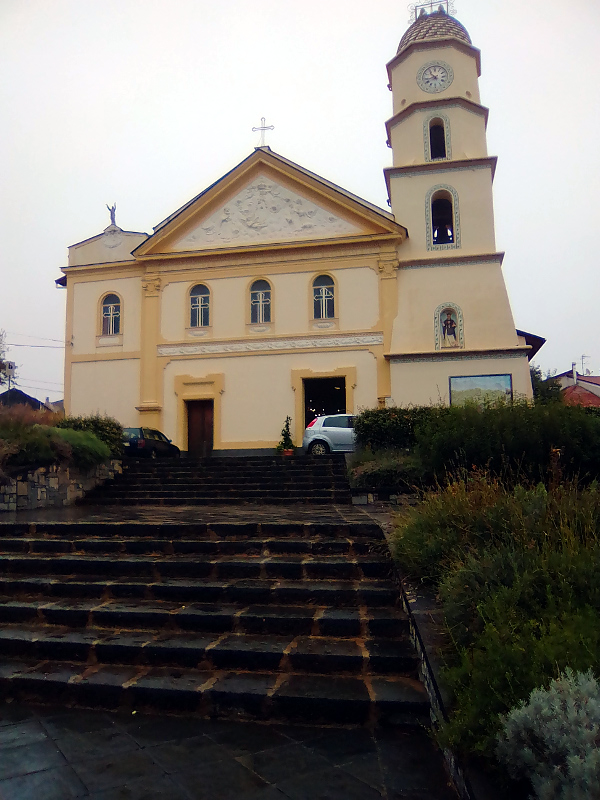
left=392, top=473, right=600, bottom=757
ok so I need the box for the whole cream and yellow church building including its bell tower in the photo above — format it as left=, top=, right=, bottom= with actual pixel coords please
left=59, top=4, right=542, bottom=453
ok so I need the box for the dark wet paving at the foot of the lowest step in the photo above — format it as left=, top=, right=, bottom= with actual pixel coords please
left=0, top=703, right=455, bottom=800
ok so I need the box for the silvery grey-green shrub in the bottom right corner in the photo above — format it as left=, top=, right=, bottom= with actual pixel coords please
left=496, top=668, right=600, bottom=800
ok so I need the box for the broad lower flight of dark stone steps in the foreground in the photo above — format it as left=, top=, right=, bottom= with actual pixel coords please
left=0, top=516, right=429, bottom=725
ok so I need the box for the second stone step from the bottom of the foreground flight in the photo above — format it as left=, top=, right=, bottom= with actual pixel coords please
left=0, top=625, right=418, bottom=678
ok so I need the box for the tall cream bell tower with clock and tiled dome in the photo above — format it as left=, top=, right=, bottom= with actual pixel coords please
left=385, top=0, right=531, bottom=405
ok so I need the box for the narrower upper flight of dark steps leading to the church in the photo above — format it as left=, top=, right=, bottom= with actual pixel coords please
left=86, top=455, right=352, bottom=505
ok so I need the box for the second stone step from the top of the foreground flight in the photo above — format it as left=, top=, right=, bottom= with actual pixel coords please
left=0, top=536, right=389, bottom=561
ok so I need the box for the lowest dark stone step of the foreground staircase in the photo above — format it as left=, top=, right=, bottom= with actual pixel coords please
left=0, top=659, right=429, bottom=726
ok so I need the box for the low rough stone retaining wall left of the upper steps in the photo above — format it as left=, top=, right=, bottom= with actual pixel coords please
left=0, top=460, right=122, bottom=512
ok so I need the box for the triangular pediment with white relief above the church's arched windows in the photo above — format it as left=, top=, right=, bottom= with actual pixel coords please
left=135, top=153, right=404, bottom=257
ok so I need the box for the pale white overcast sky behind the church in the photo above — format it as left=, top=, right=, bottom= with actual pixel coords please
left=0, top=0, right=600, bottom=399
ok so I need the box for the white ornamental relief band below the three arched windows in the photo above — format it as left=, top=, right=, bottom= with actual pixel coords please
left=157, top=333, right=383, bottom=356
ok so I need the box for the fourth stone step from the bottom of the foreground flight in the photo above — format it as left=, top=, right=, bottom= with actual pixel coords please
left=0, top=575, right=398, bottom=608
